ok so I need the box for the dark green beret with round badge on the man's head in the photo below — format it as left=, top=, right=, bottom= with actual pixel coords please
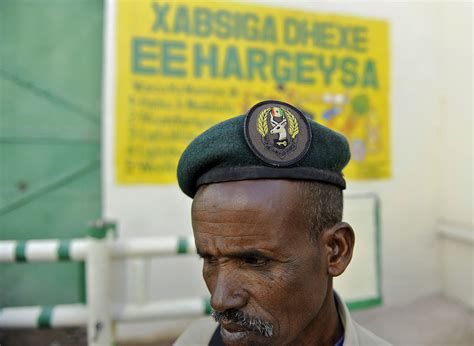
left=177, top=101, right=350, bottom=198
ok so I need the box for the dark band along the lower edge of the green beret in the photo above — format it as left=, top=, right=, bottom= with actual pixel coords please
left=191, top=166, right=346, bottom=197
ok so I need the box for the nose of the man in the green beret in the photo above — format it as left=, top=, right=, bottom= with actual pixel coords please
left=211, top=268, right=248, bottom=312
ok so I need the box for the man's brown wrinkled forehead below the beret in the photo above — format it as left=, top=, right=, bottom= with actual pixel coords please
left=192, top=179, right=309, bottom=254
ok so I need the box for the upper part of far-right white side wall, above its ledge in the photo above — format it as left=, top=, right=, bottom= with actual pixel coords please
left=439, top=3, right=474, bottom=228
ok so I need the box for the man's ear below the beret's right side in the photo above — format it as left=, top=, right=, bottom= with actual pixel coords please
left=321, top=222, right=355, bottom=277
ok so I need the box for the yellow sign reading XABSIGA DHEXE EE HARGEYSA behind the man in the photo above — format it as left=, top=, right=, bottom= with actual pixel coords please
left=116, top=1, right=390, bottom=184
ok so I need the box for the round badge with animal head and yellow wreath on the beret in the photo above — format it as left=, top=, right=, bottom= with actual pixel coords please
left=244, top=101, right=311, bottom=166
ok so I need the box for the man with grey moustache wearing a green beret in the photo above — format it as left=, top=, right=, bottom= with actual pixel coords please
left=176, top=101, right=387, bottom=346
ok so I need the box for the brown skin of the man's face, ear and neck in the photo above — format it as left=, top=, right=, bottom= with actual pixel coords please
left=192, top=180, right=354, bottom=346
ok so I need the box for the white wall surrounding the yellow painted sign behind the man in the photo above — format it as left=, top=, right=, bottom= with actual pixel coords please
left=103, top=1, right=473, bottom=338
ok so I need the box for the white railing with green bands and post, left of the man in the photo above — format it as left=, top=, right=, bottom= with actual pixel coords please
left=0, top=221, right=210, bottom=346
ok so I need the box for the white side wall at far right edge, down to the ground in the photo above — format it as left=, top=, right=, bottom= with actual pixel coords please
left=437, top=3, right=474, bottom=309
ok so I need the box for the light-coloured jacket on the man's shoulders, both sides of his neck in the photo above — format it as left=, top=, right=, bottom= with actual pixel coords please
left=174, top=293, right=390, bottom=346
